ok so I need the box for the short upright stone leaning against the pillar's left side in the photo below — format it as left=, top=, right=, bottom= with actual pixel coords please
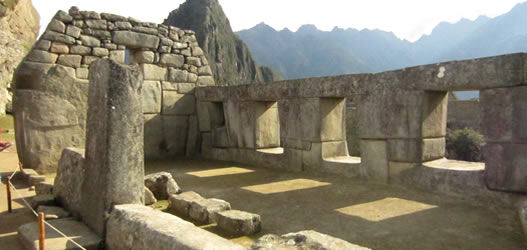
left=53, top=148, right=85, bottom=217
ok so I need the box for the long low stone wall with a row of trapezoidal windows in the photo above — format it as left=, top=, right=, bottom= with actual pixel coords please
left=197, top=54, right=527, bottom=192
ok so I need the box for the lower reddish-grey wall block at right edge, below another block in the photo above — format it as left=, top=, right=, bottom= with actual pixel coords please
left=483, top=143, right=527, bottom=192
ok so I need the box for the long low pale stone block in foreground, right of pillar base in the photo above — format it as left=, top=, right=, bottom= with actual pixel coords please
left=106, top=205, right=244, bottom=250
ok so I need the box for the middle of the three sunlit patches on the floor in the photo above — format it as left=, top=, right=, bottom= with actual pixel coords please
left=242, top=179, right=331, bottom=194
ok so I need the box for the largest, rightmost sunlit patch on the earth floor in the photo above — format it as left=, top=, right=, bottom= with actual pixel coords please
left=336, top=197, right=437, bottom=221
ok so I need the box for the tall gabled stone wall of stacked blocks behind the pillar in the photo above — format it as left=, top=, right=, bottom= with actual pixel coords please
left=13, top=7, right=214, bottom=172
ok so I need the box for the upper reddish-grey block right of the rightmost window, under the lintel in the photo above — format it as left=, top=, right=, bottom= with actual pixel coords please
left=480, top=87, right=527, bottom=143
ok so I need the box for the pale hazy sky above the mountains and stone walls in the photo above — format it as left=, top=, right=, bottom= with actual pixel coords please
left=33, top=0, right=526, bottom=41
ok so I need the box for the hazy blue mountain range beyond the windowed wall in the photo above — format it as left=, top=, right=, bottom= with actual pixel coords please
left=237, top=2, right=527, bottom=79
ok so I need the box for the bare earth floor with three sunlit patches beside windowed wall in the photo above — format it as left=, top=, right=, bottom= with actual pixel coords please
left=146, top=160, right=527, bottom=249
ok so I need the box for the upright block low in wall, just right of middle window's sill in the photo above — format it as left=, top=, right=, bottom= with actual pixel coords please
left=360, top=140, right=389, bottom=183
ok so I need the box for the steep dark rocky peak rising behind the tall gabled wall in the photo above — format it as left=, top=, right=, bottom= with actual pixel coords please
left=164, top=0, right=282, bottom=85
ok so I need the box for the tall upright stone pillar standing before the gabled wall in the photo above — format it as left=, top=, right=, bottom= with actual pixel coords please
left=82, top=59, right=144, bottom=237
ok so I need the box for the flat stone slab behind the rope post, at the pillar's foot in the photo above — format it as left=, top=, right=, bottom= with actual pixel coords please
left=17, top=219, right=102, bottom=250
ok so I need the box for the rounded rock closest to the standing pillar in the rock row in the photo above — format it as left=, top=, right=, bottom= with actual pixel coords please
left=144, top=172, right=181, bottom=200
